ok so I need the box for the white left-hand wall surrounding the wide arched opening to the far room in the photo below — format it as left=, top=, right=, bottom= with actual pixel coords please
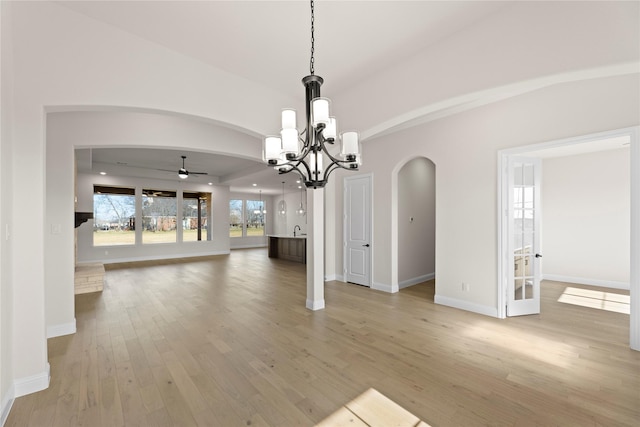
left=8, top=2, right=293, bottom=393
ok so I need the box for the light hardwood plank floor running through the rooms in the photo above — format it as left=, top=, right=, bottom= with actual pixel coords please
left=6, top=249, right=640, bottom=426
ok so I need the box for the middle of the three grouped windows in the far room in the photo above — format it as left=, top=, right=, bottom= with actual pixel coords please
left=142, top=190, right=178, bottom=244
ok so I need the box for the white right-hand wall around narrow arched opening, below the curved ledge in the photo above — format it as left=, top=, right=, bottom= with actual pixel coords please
left=335, top=74, right=640, bottom=315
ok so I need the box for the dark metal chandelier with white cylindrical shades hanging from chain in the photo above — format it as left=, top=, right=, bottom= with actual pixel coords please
left=262, top=0, right=362, bottom=188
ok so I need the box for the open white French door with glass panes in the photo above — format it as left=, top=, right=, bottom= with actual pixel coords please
left=507, top=156, right=542, bottom=316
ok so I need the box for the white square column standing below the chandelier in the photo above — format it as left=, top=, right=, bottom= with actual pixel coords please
left=306, top=188, right=324, bottom=310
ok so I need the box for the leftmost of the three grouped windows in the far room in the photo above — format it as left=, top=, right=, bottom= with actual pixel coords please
left=93, top=185, right=136, bottom=246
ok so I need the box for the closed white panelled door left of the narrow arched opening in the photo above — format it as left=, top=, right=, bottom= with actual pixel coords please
left=344, top=175, right=371, bottom=286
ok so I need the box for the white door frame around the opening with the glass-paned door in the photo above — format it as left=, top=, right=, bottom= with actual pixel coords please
left=497, top=126, right=640, bottom=351
